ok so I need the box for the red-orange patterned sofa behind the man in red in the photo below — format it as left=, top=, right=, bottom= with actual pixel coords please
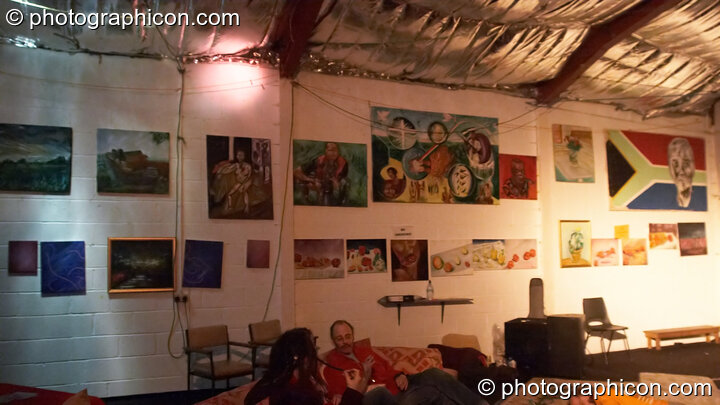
left=198, top=340, right=457, bottom=405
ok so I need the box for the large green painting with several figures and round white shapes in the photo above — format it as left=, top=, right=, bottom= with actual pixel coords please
left=370, top=107, right=500, bottom=204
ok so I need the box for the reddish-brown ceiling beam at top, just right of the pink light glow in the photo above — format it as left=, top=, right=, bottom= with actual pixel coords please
left=270, top=0, right=323, bottom=79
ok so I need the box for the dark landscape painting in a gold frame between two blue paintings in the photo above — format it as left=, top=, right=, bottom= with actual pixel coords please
left=108, top=238, right=175, bottom=293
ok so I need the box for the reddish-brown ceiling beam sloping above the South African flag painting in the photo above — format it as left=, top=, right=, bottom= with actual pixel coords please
left=535, top=0, right=681, bottom=105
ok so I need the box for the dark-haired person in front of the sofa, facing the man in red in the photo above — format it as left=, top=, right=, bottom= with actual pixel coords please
left=245, top=328, right=367, bottom=405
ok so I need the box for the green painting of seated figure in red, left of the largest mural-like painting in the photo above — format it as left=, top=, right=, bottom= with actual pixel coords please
left=293, top=139, right=367, bottom=207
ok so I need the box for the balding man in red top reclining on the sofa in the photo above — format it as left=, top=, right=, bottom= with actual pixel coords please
left=323, top=320, right=486, bottom=405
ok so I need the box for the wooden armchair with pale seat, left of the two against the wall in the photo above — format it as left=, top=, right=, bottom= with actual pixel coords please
left=185, top=325, right=254, bottom=390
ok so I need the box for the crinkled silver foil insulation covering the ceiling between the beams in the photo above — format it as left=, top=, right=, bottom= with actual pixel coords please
left=0, top=0, right=720, bottom=117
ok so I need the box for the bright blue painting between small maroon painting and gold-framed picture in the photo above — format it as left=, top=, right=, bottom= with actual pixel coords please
left=40, top=242, right=85, bottom=295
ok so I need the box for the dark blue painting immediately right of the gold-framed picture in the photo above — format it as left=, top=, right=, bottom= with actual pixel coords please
left=183, top=239, right=223, bottom=288
